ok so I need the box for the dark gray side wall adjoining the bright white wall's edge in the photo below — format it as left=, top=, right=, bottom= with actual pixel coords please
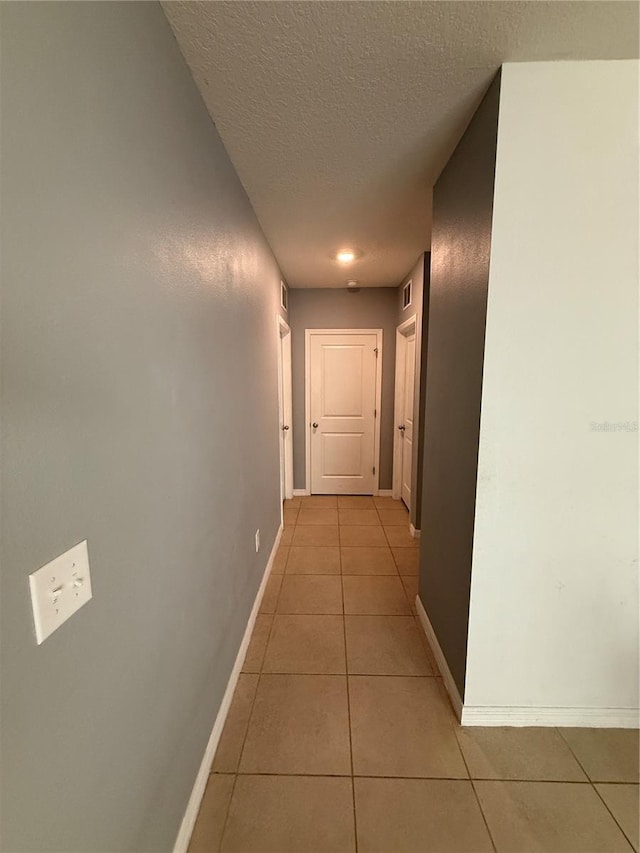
left=419, top=77, right=500, bottom=696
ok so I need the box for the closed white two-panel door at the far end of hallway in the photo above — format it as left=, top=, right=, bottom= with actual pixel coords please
left=307, top=330, right=381, bottom=495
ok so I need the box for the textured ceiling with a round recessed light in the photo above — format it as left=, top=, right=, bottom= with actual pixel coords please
left=163, top=0, right=638, bottom=287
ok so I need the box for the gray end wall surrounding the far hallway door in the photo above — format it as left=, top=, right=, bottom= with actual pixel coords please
left=289, top=287, right=398, bottom=489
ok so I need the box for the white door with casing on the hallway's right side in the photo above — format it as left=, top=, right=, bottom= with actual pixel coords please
left=393, top=316, right=416, bottom=510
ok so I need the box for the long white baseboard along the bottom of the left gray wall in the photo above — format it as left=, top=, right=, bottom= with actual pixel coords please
left=173, top=527, right=282, bottom=853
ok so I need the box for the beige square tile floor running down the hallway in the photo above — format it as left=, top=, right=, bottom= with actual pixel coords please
left=190, top=496, right=639, bottom=853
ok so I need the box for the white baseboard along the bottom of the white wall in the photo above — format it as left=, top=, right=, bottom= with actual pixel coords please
left=461, top=705, right=640, bottom=729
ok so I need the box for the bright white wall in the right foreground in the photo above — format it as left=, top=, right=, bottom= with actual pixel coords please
left=464, top=61, right=639, bottom=725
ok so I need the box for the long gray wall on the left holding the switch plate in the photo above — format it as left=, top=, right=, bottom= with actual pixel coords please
left=0, top=3, right=280, bottom=853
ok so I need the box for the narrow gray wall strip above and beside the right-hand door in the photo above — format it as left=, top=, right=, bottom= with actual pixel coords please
left=397, top=252, right=429, bottom=530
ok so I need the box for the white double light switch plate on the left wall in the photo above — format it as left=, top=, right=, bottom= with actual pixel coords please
left=29, top=539, right=91, bottom=645
